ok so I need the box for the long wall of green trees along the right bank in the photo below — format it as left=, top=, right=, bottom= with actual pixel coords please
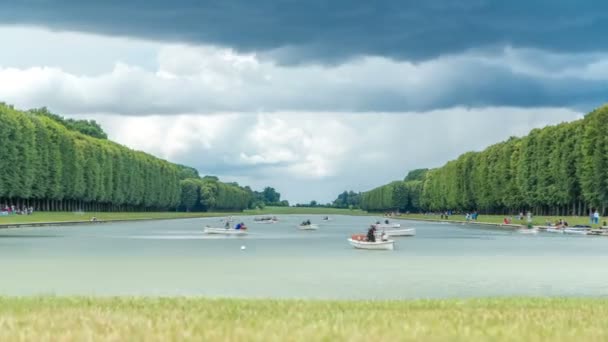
left=361, top=106, right=608, bottom=215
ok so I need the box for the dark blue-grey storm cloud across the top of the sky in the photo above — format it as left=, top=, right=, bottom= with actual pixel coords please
left=0, top=0, right=608, bottom=64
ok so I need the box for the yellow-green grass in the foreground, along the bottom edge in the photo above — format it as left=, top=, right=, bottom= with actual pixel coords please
left=0, top=297, right=608, bottom=341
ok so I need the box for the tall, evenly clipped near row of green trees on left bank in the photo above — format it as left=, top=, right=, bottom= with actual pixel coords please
left=0, top=105, right=179, bottom=210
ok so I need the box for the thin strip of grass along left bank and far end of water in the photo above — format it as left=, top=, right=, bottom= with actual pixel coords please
left=0, top=207, right=367, bottom=225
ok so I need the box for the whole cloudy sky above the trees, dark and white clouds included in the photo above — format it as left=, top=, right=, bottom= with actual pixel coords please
left=0, top=0, right=608, bottom=203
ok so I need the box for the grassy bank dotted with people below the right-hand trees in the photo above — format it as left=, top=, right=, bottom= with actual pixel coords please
left=400, top=214, right=607, bottom=227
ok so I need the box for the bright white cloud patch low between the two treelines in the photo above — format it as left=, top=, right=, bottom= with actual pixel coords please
left=88, top=108, right=581, bottom=202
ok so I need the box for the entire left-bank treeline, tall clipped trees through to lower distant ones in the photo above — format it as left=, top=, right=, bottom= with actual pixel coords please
left=0, top=103, right=284, bottom=211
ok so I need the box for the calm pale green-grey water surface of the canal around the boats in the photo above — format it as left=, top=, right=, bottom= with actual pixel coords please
left=0, top=215, right=608, bottom=299
